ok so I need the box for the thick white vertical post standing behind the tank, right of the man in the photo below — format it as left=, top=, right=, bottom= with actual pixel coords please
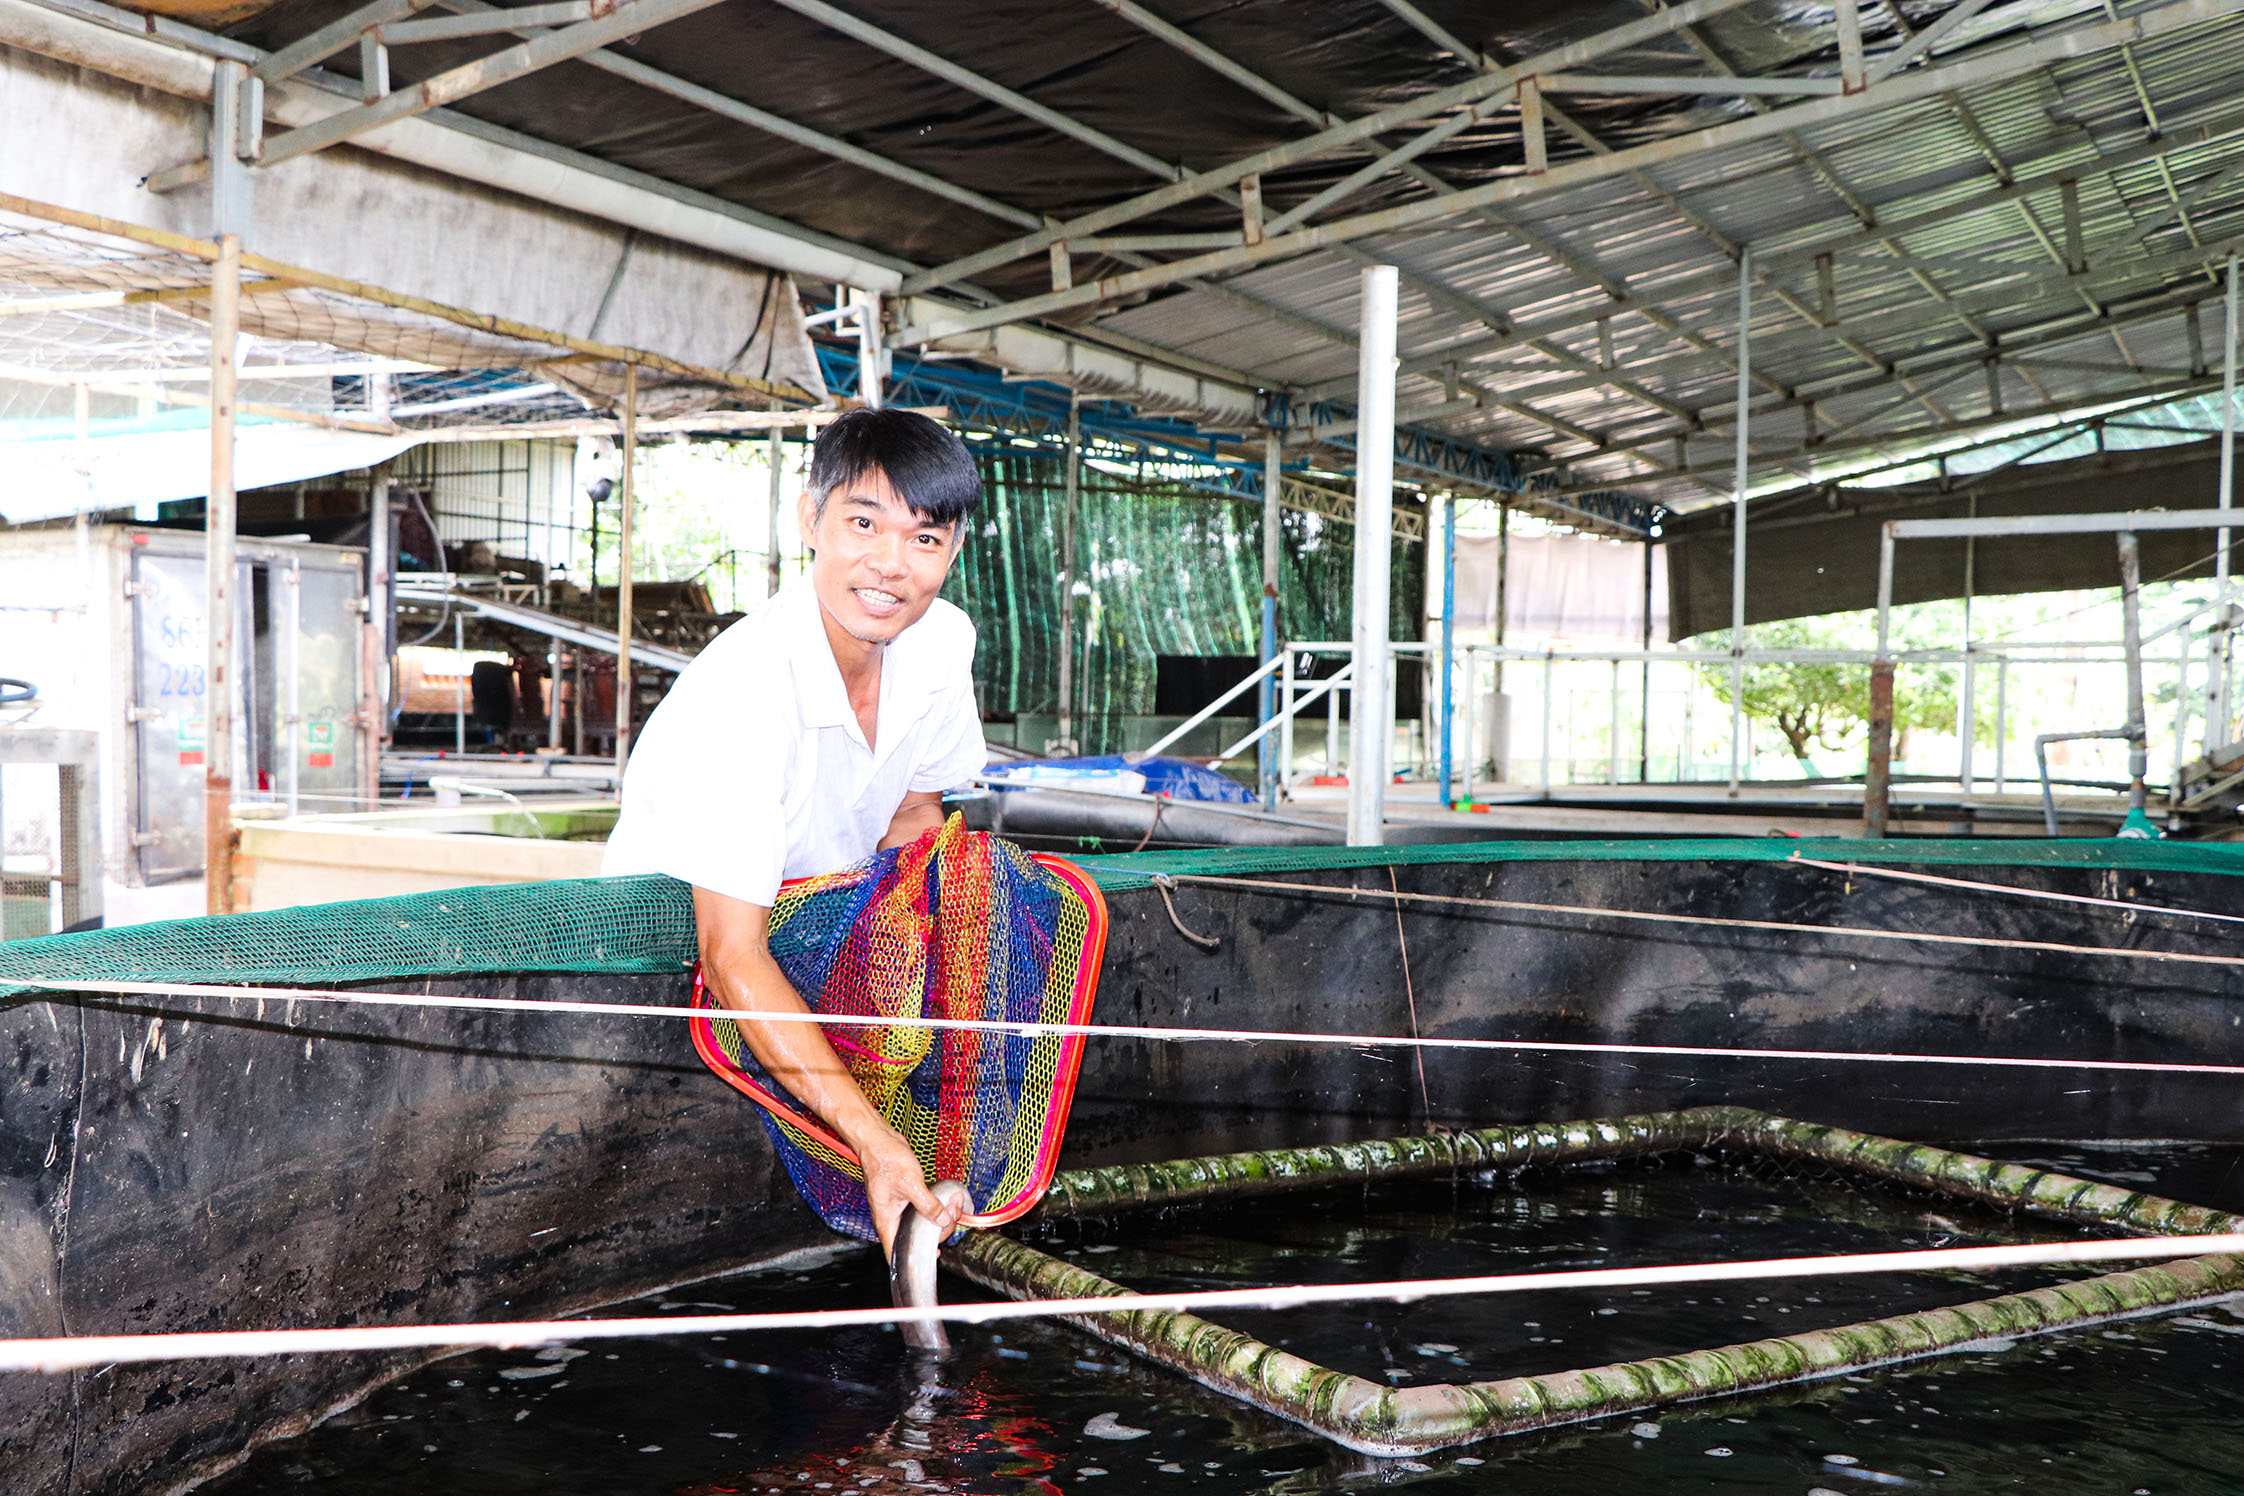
left=1349, top=265, right=1396, bottom=846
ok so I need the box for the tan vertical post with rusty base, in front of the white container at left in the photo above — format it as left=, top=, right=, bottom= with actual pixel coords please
left=202, top=232, right=242, bottom=915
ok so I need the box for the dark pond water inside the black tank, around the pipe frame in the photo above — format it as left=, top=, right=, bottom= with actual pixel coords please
left=204, top=1146, right=2244, bottom=1496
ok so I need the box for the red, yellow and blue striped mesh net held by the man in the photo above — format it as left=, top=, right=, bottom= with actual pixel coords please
left=691, top=814, right=1106, bottom=1240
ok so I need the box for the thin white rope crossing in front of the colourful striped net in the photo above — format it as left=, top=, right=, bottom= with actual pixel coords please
left=9, top=976, right=2244, bottom=1077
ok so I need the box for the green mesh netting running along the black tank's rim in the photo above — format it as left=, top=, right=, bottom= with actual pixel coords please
left=0, top=837, right=2244, bottom=994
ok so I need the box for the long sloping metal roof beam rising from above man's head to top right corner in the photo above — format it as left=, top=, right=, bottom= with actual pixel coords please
left=893, top=0, right=2244, bottom=343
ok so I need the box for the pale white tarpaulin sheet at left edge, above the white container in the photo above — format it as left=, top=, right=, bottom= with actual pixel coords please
left=0, top=415, right=420, bottom=525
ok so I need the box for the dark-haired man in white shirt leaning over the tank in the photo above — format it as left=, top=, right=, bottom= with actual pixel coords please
left=601, top=410, right=987, bottom=1247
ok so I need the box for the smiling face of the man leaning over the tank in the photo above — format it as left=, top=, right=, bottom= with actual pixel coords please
left=797, top=467, right=958, bottom=644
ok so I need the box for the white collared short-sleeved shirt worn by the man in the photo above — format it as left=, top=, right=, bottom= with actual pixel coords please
left=599, top=588, right=987, bottom=908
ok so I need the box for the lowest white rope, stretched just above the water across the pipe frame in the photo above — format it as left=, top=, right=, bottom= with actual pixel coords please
left=0, top=1234, right=2244, bottom=1373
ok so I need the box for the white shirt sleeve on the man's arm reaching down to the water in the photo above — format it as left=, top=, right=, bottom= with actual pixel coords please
left=599, top=645, right=794, bottom=908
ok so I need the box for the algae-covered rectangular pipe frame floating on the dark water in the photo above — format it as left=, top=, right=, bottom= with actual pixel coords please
left=945, top=1108, right=2244, bottom=1456
